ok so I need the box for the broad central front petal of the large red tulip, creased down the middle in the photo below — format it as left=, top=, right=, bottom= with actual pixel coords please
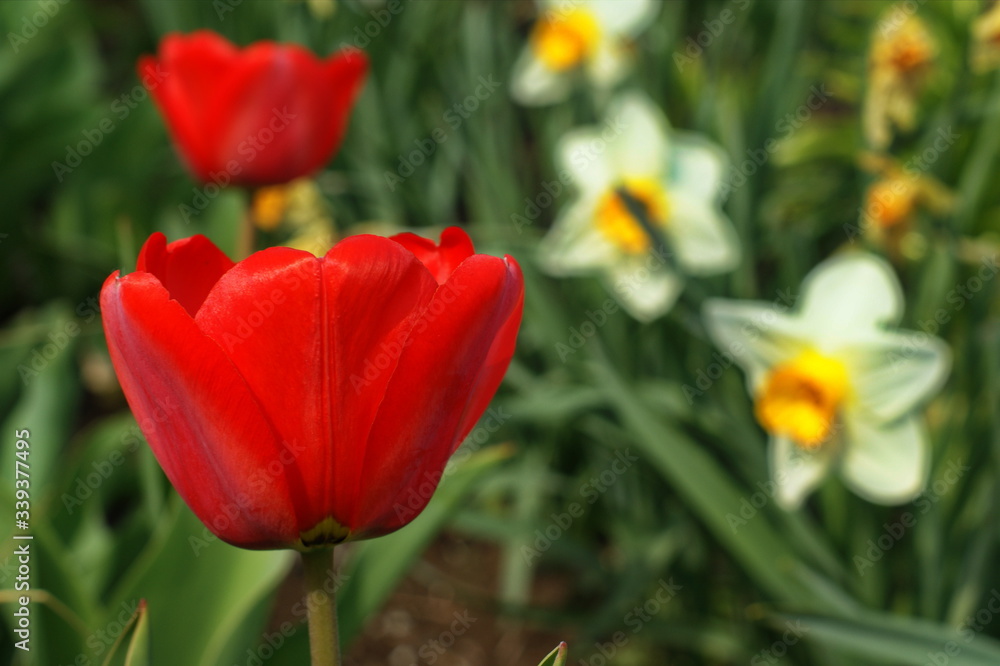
left=197, top=236, right=436, bottom=531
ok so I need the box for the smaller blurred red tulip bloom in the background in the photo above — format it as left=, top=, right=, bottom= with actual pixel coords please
left=139, top=30, right=368, bottom=186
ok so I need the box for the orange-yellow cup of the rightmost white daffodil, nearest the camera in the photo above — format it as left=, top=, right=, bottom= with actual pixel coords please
left=754, top=351, right=849, bottom=449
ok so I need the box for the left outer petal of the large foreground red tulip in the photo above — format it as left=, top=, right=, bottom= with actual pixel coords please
left=101, top=273, right=302, bottom=548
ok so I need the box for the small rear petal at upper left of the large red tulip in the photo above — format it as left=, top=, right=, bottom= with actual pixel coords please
left=135, top=232, right=233, bottom=317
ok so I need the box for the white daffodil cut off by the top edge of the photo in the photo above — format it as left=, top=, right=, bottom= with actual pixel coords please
left=511, top=0, right=657, bottom=106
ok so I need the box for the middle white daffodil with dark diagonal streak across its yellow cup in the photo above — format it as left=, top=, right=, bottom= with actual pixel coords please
left=540, top=94, right=739, bottom=321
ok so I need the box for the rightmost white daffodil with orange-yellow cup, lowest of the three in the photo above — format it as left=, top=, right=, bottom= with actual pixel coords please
left=705, top=253, right=950, bottom=508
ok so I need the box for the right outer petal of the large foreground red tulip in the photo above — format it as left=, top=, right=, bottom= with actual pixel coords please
left=352, top=255, right=523, bottom=534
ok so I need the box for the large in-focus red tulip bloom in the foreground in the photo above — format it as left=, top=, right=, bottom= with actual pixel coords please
left=101, top=228, right=524, bottom=549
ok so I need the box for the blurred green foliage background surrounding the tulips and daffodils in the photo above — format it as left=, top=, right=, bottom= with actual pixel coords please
left=0, top=0, right=1000, bottom=666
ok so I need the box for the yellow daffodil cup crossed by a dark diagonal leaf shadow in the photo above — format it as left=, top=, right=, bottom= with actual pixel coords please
left=595, top=178, right=670, bottom=254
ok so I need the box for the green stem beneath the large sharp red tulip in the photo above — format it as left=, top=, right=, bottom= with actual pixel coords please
left=302, top=549, right=340, bottom=666
